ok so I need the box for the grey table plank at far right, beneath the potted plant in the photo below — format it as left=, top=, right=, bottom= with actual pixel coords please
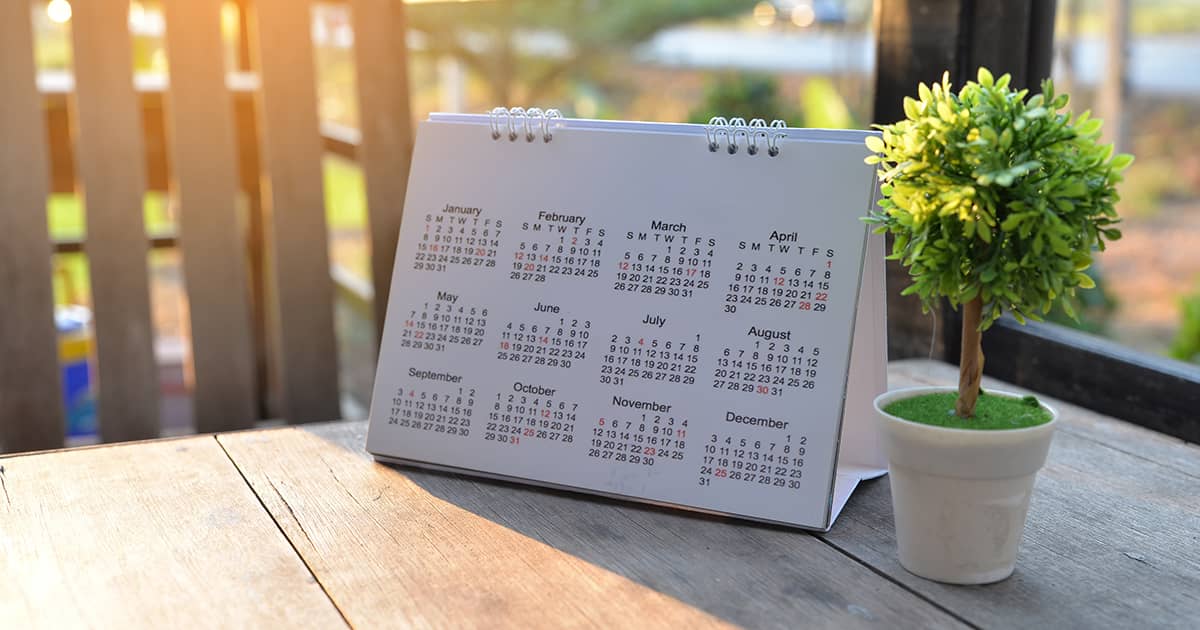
left=823, top=362, right=1200, bottom=628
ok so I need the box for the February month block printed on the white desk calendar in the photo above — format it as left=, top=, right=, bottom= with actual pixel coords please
left=509, top=212, right=605, bottom=282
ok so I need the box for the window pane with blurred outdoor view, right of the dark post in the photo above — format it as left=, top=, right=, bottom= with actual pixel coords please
left=1054, top=0, right=1200, bottom=372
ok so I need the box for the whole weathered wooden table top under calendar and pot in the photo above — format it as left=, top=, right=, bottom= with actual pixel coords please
left=0, top=361, right=1200, bottom=629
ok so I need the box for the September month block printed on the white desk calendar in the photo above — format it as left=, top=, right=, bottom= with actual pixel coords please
left=388, top=368, right=475, bottom=438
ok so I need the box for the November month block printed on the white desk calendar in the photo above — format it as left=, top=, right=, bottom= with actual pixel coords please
left=588, top=396, right=688, bottom=466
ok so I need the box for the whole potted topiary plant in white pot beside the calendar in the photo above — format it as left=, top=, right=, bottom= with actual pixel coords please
left=865, top=68, right=1133, bottom=583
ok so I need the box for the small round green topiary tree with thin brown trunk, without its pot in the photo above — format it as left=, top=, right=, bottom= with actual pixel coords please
left=866, top=68, right=1133, bottom=418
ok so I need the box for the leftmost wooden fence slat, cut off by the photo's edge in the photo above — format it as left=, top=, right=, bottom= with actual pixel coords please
left=0, top=2, right=64, bottom=452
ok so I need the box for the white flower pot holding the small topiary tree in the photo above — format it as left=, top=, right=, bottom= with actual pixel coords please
left=875, top=388, right=1058, bottom=584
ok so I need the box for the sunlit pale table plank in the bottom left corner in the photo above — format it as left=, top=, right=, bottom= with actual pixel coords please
left=0, top=437, right=344, bottom=629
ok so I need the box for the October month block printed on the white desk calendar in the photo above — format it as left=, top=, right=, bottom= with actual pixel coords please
left=484, top=383, right=580, bottom=446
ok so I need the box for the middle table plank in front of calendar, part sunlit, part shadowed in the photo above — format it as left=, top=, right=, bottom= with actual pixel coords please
left=217, top=422, right=959, bottom=628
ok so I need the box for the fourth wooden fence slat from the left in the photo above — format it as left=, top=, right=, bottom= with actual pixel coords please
left=251, top=0, right=341, bottom=422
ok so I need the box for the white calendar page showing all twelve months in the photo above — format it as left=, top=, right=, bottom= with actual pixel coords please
left=367, top=116, right=882, bottom=529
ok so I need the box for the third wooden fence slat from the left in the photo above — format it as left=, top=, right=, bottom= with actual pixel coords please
left=163, top=0, right=257, bottom=433
